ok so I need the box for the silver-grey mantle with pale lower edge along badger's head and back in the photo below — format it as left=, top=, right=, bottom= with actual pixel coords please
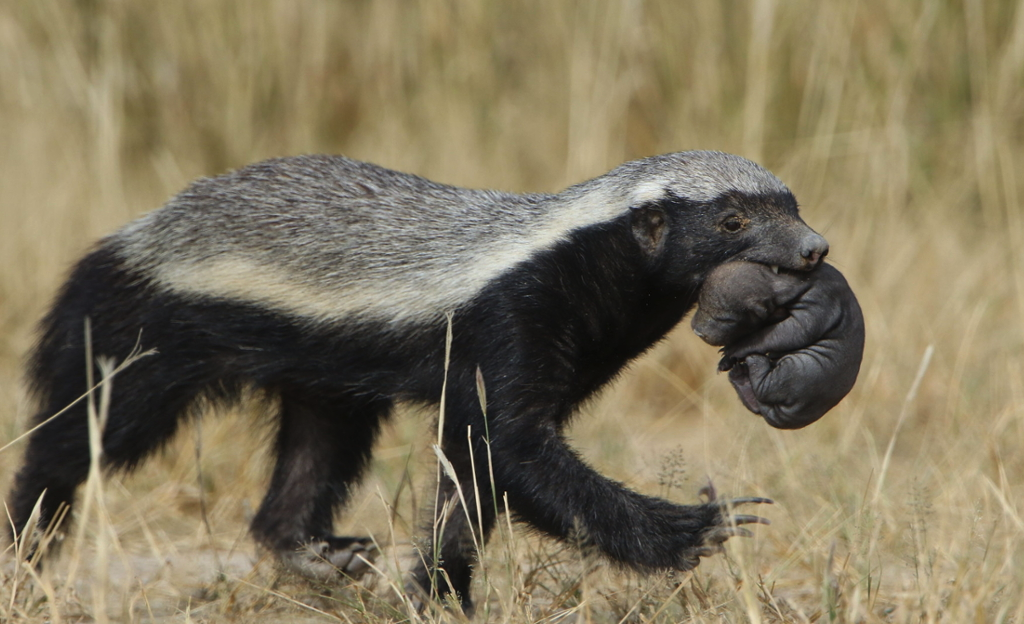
left=112, top=152, right=788, bottom=323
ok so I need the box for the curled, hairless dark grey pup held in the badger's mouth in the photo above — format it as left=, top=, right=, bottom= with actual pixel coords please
left=691, top=262, right=864, bottom=429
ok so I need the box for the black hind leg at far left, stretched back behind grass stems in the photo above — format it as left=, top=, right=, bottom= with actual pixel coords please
left=8, top=250, right=217, bottom=557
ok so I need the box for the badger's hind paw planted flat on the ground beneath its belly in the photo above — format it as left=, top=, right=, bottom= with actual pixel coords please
left=278, top=536, right=377, bottom=581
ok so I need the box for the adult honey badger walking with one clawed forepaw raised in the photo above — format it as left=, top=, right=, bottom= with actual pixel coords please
left=9, top=152, right=828, bottom=607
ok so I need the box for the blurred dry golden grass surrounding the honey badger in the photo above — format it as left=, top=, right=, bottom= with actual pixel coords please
left=0, top=0, right=1024, bottom=622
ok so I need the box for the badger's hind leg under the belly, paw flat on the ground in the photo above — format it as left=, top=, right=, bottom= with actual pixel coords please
left=251, top=387, right=391, bottom=581
